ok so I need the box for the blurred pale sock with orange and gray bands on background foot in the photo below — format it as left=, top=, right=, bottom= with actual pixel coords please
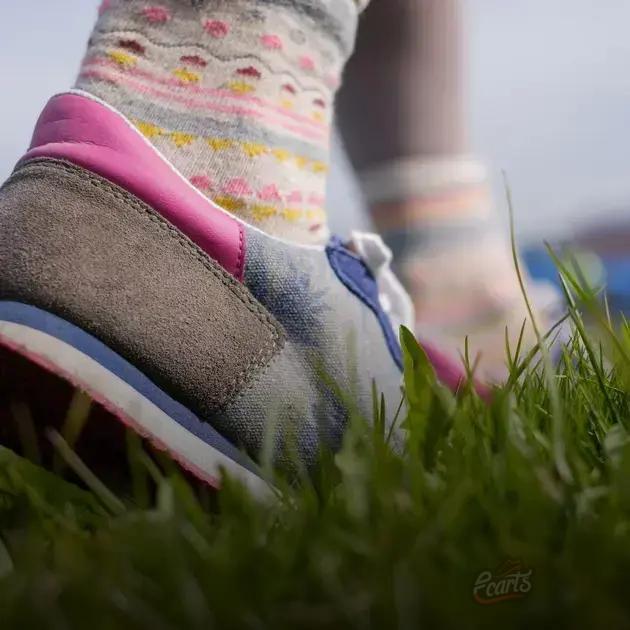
left=363, top=158, right=558, bottom=380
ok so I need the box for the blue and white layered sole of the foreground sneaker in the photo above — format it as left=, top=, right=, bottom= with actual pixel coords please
left=0, top=301, right=272, bottom=498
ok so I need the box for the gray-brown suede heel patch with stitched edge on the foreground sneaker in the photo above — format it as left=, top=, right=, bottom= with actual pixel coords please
left=0, top=159, right=285, bottom=417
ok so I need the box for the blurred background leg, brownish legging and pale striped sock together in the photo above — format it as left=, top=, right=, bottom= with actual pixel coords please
left=339, top=0, right=556, bottom=378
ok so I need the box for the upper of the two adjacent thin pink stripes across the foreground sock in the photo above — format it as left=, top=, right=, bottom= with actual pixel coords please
left=84, top=57, right=328, bottom=132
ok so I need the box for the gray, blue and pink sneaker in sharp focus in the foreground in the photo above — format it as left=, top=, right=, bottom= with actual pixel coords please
left=0, top=92, right=466, bottom=492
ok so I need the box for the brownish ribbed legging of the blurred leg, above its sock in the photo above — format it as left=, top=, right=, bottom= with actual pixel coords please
left=339, top=0, right=468, bottom=171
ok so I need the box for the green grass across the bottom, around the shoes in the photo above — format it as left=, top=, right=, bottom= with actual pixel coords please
left=0, top=262, right=630, bottom=630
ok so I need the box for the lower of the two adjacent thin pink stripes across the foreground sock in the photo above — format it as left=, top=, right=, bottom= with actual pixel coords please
left=80, top=68, right=329, bottom=149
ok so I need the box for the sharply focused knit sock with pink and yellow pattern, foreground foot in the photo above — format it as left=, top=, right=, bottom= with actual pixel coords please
left=76, top=0, right=363, bottom=243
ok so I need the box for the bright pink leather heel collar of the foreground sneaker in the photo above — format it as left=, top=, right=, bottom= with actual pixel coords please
left=20, top=94, right=245, bottom=280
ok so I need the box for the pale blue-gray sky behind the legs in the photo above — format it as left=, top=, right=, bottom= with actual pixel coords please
left=0, top=0, right=630, bottom=242
